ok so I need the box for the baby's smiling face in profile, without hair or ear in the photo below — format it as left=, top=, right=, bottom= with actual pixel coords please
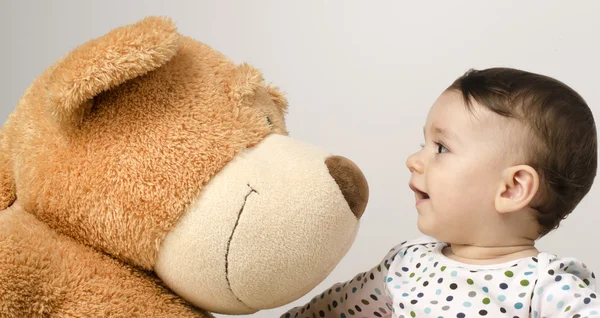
left=407, top=91, right=518, bottom=244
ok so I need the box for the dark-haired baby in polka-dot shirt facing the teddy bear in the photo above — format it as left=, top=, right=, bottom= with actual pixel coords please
left=281, top=68, right=600, bottom=318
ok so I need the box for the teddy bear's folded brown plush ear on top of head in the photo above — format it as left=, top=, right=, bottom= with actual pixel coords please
left=47, top=17, right=180, bottom=129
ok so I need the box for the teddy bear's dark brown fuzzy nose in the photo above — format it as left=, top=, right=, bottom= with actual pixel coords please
left=325, top=156, right=369, bottom=219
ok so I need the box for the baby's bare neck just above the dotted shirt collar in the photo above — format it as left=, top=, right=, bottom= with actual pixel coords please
left=444, top=240, right=539, bottom=265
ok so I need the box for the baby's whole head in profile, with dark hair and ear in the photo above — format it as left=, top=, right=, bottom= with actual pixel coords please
left=407, top=68, right=597, bottom=245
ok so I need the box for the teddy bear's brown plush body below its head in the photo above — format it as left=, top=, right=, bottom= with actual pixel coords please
left=0, top=205, right=211, bottom=318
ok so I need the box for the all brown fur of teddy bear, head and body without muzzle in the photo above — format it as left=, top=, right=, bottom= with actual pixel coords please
left=0, top=18, right=287, bottom=317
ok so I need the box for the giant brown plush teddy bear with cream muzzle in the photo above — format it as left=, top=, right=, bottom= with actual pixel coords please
left=0, top=17, right=368, bottom=317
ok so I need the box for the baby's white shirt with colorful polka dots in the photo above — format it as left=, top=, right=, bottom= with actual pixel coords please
left=281, top=237, right=600, bottom=318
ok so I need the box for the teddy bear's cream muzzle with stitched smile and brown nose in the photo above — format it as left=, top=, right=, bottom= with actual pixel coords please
left=155, top=135, right=369, bottom=314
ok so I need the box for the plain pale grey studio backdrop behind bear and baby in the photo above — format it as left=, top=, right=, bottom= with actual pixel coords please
left=0, top=0, right=600, bottom=317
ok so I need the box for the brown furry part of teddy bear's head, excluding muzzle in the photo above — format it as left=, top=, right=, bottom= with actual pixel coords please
left=1, top=18, right=287, bottom=270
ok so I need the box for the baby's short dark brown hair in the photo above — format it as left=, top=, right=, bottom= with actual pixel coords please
left=448, top=68, right=598, bottom=236
